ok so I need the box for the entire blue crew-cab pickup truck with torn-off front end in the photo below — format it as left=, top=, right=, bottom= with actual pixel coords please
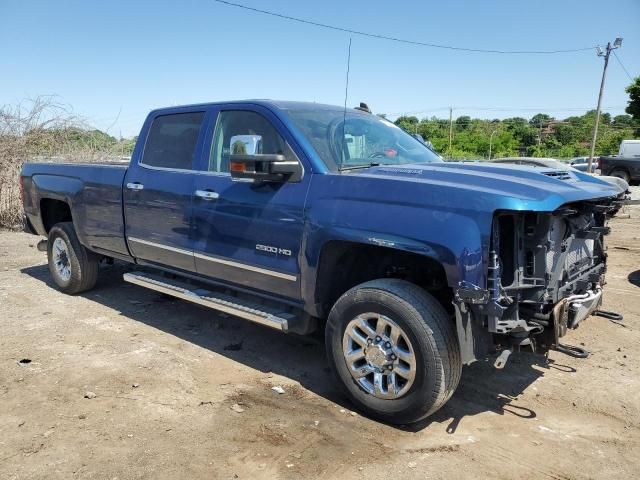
left=21, top=100, right=619, bottom=423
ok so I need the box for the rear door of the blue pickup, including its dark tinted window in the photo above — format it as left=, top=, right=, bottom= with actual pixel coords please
left=123, top=109, right=206, bottom=271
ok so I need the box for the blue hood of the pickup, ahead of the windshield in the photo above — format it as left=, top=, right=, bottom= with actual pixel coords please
left=353, top=162, right=620, bottom=211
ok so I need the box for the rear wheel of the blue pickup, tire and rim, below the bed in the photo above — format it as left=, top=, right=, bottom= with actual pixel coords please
left=47, top=222, right=100, bottom=295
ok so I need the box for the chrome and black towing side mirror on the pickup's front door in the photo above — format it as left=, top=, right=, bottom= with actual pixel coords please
left=229, top=154, right=302, bottom=182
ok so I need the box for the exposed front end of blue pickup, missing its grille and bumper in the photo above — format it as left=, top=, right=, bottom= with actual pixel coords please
left=454, top=200, right=616, bottom=368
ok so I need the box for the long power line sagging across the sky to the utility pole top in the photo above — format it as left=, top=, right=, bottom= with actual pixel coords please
left=213, top=0, right=598, bottom=55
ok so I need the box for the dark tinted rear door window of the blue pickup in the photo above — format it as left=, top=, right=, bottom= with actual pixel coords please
left=141, top=112, right=204, bottom=170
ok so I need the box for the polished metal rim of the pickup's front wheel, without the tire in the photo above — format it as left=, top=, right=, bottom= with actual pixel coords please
left=342, top=312, right=416, bottom=400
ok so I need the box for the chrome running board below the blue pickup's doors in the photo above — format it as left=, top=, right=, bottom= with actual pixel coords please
left=122, top=272, right=295, bottom=332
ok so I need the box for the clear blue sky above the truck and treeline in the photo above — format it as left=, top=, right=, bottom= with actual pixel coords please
left=0, top=0, right=640, bottom=136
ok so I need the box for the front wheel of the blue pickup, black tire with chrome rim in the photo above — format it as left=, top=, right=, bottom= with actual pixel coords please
left=325, top=279, right=462, bottom=424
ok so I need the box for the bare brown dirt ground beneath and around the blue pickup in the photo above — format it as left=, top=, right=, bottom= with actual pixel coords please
left=0, top=207, right=640, bottom=479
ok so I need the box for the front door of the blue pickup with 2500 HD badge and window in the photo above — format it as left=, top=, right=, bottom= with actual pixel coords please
left=193, top=106, right=310, bottom=300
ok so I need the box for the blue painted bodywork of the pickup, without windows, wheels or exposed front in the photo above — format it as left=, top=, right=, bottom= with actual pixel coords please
left=22, top=101, right=618, bottom=314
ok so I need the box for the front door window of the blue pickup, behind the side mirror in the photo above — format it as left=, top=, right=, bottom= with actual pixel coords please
left=209, top=110, right=291, bottom=172
